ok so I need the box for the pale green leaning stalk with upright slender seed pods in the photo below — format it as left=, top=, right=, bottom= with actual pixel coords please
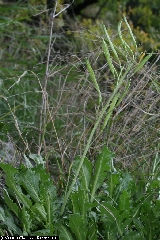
left=61, top=17, right=152, bottom=214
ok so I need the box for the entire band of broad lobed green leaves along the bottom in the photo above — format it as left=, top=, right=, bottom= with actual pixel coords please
left=0, top=147, right=160, bottom=237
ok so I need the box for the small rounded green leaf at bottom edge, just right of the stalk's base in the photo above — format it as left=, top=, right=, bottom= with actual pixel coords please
left=69, top=214, right=87, bottom=240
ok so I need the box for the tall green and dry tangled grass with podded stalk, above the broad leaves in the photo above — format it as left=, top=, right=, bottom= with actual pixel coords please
left=1, top=2, right=159, bottom=180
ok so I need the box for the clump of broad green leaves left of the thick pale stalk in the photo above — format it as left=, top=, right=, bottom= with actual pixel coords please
left=0, top=158, right=57, bottom=236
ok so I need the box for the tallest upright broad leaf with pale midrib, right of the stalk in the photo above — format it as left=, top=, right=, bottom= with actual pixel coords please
left=91, top=147, right=113, bottom=202
